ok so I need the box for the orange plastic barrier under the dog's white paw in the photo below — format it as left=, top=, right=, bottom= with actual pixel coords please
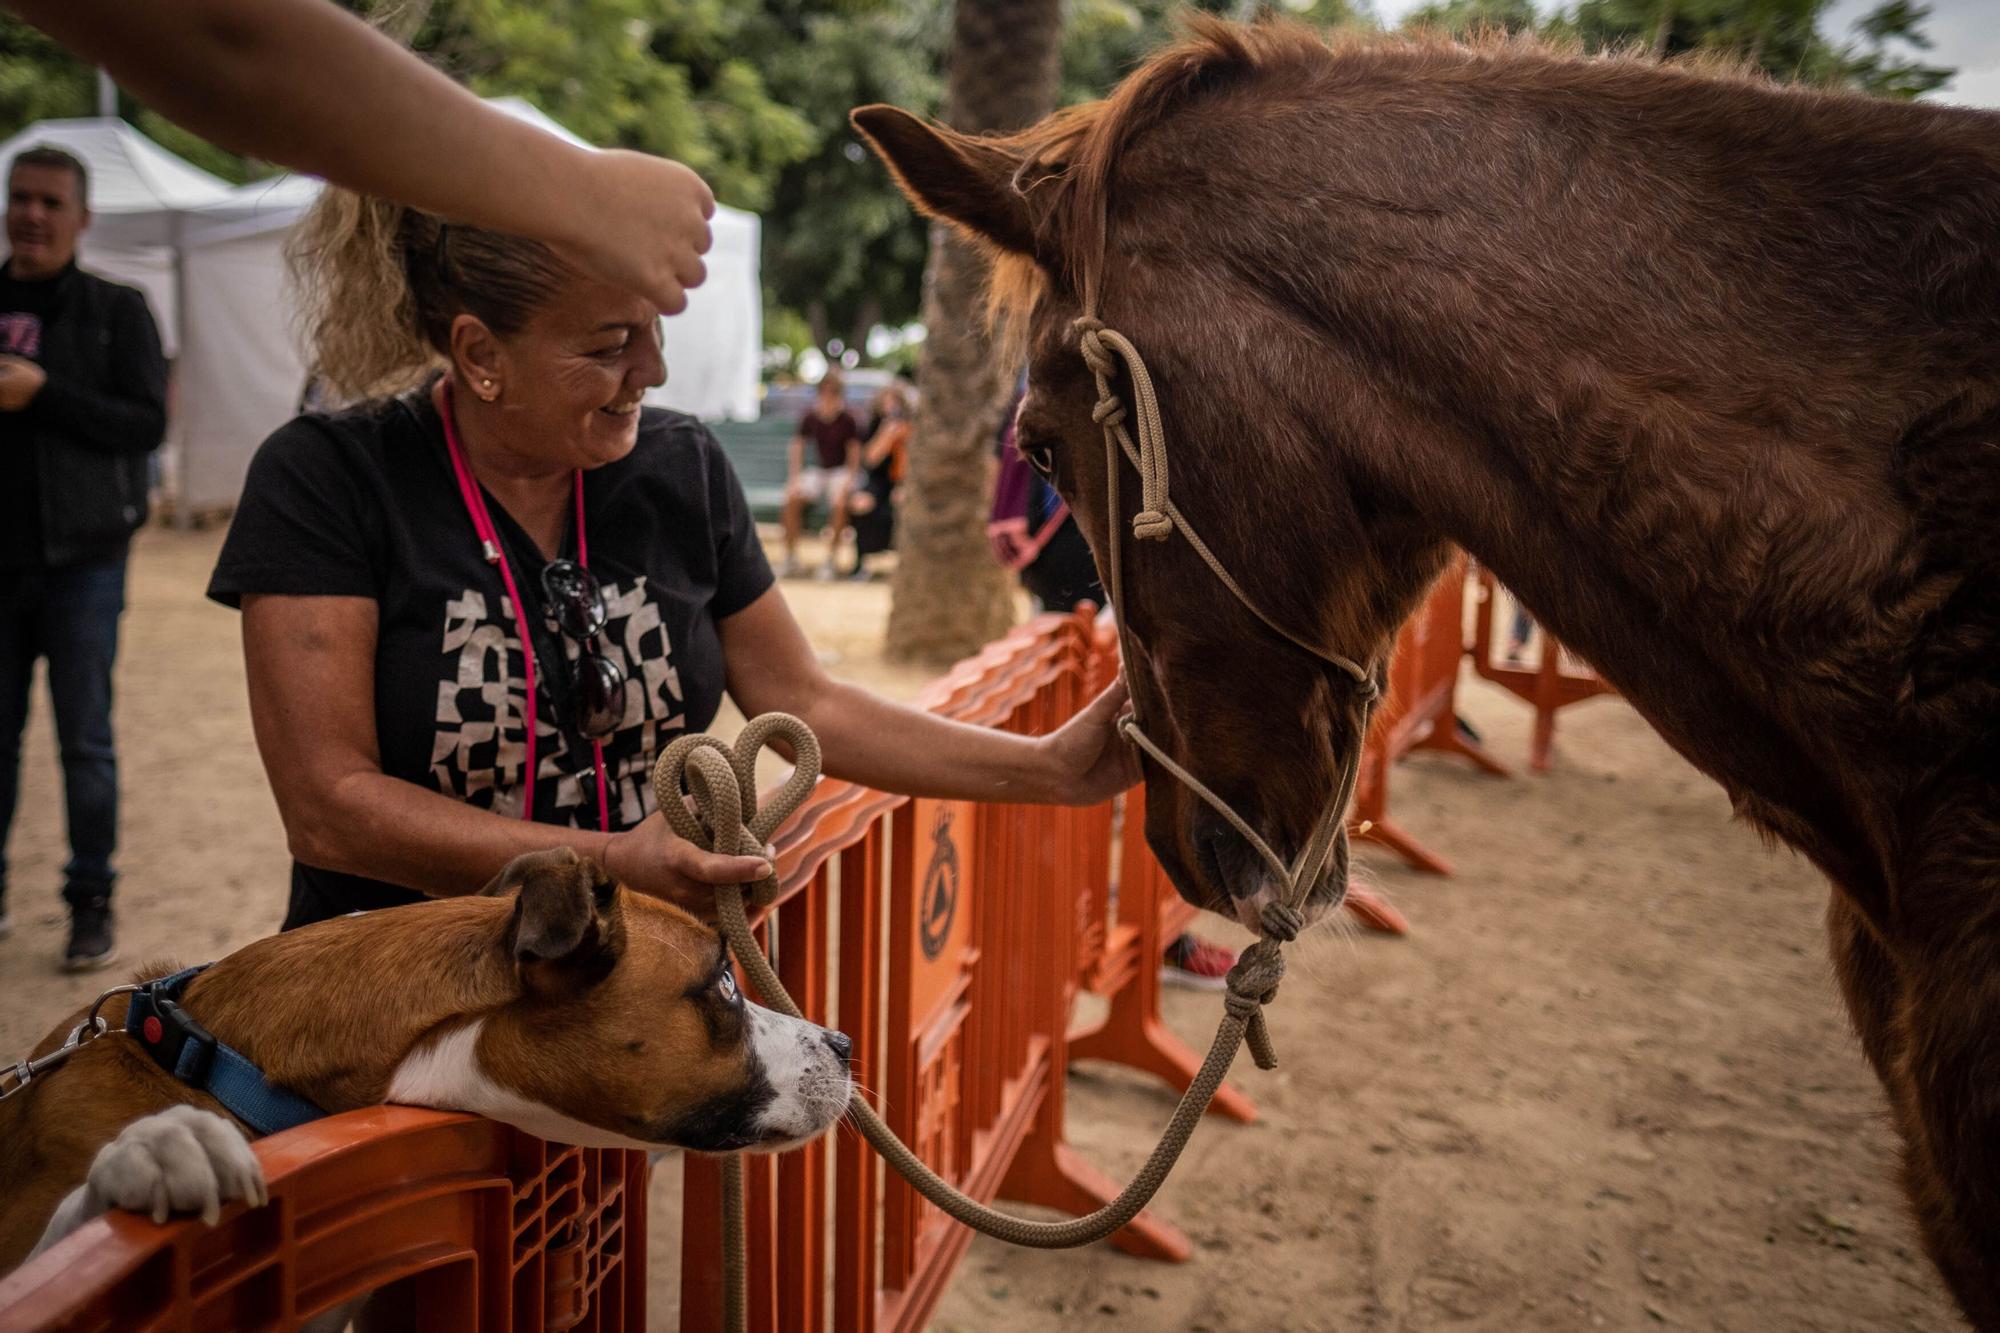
left=0, top=1107, right=646, bottom=1333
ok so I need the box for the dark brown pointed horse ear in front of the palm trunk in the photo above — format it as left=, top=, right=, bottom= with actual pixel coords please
left=848, top=106, right=1036, bottom=258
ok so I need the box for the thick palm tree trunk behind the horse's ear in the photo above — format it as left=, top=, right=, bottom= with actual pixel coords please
left=888, top=0, right=1062, bottom=667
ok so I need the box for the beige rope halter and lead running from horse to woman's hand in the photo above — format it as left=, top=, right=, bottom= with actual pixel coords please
left=652, top=314, right=1380, bottom=1333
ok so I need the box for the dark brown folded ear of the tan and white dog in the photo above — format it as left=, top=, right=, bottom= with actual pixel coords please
left=482, top=847, right=626, bottom=989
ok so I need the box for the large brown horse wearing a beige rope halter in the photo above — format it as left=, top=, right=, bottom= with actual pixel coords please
left=856, top=22, right=2000, bottom=1329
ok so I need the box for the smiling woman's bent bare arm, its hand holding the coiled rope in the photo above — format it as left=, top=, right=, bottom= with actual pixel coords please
left=244, top=596, right=768, bottom=911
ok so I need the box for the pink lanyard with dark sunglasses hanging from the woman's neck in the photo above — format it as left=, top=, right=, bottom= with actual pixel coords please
left=432, top=378, right=626, bottom=833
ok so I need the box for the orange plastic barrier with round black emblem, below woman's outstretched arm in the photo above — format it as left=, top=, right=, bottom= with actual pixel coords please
left=682, top=614, right=1216, bottom=1329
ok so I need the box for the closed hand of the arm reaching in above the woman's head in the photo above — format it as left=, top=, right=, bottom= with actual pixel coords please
left=562, top=150, right=716, bottom=314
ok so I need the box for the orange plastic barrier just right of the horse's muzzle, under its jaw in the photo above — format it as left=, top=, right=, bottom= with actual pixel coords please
left=1352, top=554, right=1510, bottom=875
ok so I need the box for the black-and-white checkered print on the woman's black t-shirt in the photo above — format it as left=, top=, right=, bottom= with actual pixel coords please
left=430, top=576, right=688, bottom=829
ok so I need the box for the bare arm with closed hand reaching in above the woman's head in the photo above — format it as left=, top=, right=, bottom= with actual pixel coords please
left=0, top=0, right=716, bottom=314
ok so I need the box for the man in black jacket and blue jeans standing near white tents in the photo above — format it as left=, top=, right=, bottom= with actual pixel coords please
left=0, top=148, right=166, bottom=971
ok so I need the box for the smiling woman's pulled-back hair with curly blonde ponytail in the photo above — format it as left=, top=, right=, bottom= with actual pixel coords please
left=286, top=188, right=570, bottom=402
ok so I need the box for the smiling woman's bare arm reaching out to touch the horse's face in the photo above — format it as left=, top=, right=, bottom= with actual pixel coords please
left=720, top=586, right=1138, bottom=805
